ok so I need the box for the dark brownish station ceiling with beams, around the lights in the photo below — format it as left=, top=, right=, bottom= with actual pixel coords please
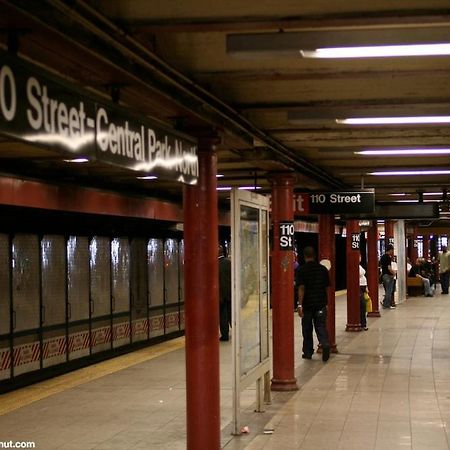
left=0, top=0, right=450, bottom=221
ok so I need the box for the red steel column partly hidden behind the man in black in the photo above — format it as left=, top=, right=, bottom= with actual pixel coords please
left=319, top=214, right=338, bottom=353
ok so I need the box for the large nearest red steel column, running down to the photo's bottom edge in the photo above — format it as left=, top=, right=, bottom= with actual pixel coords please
left=183, top=139, right=220, bottom=450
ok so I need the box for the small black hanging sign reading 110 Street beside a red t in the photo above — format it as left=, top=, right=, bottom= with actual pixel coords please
left=294, top=189, right=375, bottom=215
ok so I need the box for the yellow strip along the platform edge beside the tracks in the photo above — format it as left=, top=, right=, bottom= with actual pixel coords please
left=0, top=337, right=184, bottom=416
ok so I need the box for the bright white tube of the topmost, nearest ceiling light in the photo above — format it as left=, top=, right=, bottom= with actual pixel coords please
left=300, top=43, right=450, bottom=58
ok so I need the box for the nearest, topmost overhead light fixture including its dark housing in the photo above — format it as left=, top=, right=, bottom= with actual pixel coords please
left=226, top=24, right=450, bottom=58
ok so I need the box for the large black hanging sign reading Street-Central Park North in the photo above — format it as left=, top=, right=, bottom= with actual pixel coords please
left=0, top=53, right=198, bottom=184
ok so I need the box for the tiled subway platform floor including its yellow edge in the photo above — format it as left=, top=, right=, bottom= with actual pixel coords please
left=0, top=289, right=450, bottom=450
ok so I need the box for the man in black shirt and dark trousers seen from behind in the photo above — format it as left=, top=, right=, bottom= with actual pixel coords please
left=297, top=247, right=330, bottom=362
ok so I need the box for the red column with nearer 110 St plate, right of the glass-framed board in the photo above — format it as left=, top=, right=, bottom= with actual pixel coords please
left=271, top=174, right=298, bottom=391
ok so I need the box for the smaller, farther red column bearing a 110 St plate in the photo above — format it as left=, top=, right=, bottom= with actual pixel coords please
left=345, top=220, right=361, bottom=331
